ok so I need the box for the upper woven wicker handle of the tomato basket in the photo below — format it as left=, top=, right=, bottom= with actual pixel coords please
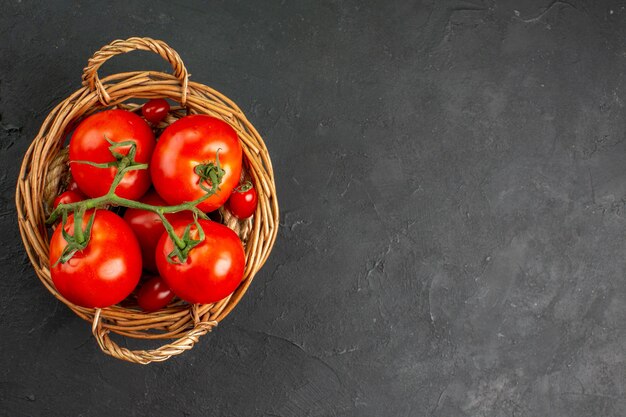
left=83, top=37, right=189, bottom=106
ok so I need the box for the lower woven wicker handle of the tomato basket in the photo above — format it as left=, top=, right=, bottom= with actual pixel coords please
left=91, top=305, right=217, bottom=365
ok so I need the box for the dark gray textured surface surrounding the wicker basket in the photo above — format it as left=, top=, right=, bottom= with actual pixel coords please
left=0, top=0, right=626, bottom=417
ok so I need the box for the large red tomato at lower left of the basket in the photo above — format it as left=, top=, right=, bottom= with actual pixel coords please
left=49, top=210, right=141, bottom=308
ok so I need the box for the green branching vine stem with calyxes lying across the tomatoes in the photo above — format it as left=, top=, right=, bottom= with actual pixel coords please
left=46, top=136, right=225, bottom=266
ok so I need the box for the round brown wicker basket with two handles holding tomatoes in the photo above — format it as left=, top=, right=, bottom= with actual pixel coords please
left=16, top=38, right=278, bottom=364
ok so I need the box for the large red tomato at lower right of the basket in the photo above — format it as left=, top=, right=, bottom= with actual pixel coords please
left=156, top=220, right=245, bottom=304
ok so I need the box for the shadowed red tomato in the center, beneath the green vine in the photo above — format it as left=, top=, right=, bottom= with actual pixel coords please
left=124, top=191, right=193, bottom=273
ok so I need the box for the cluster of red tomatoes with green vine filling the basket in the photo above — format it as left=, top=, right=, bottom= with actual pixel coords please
left=49, top=99, right=257, bottom=311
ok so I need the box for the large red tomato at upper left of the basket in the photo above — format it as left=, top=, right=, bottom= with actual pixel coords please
left=70, top=110, right=155, bottom=200
